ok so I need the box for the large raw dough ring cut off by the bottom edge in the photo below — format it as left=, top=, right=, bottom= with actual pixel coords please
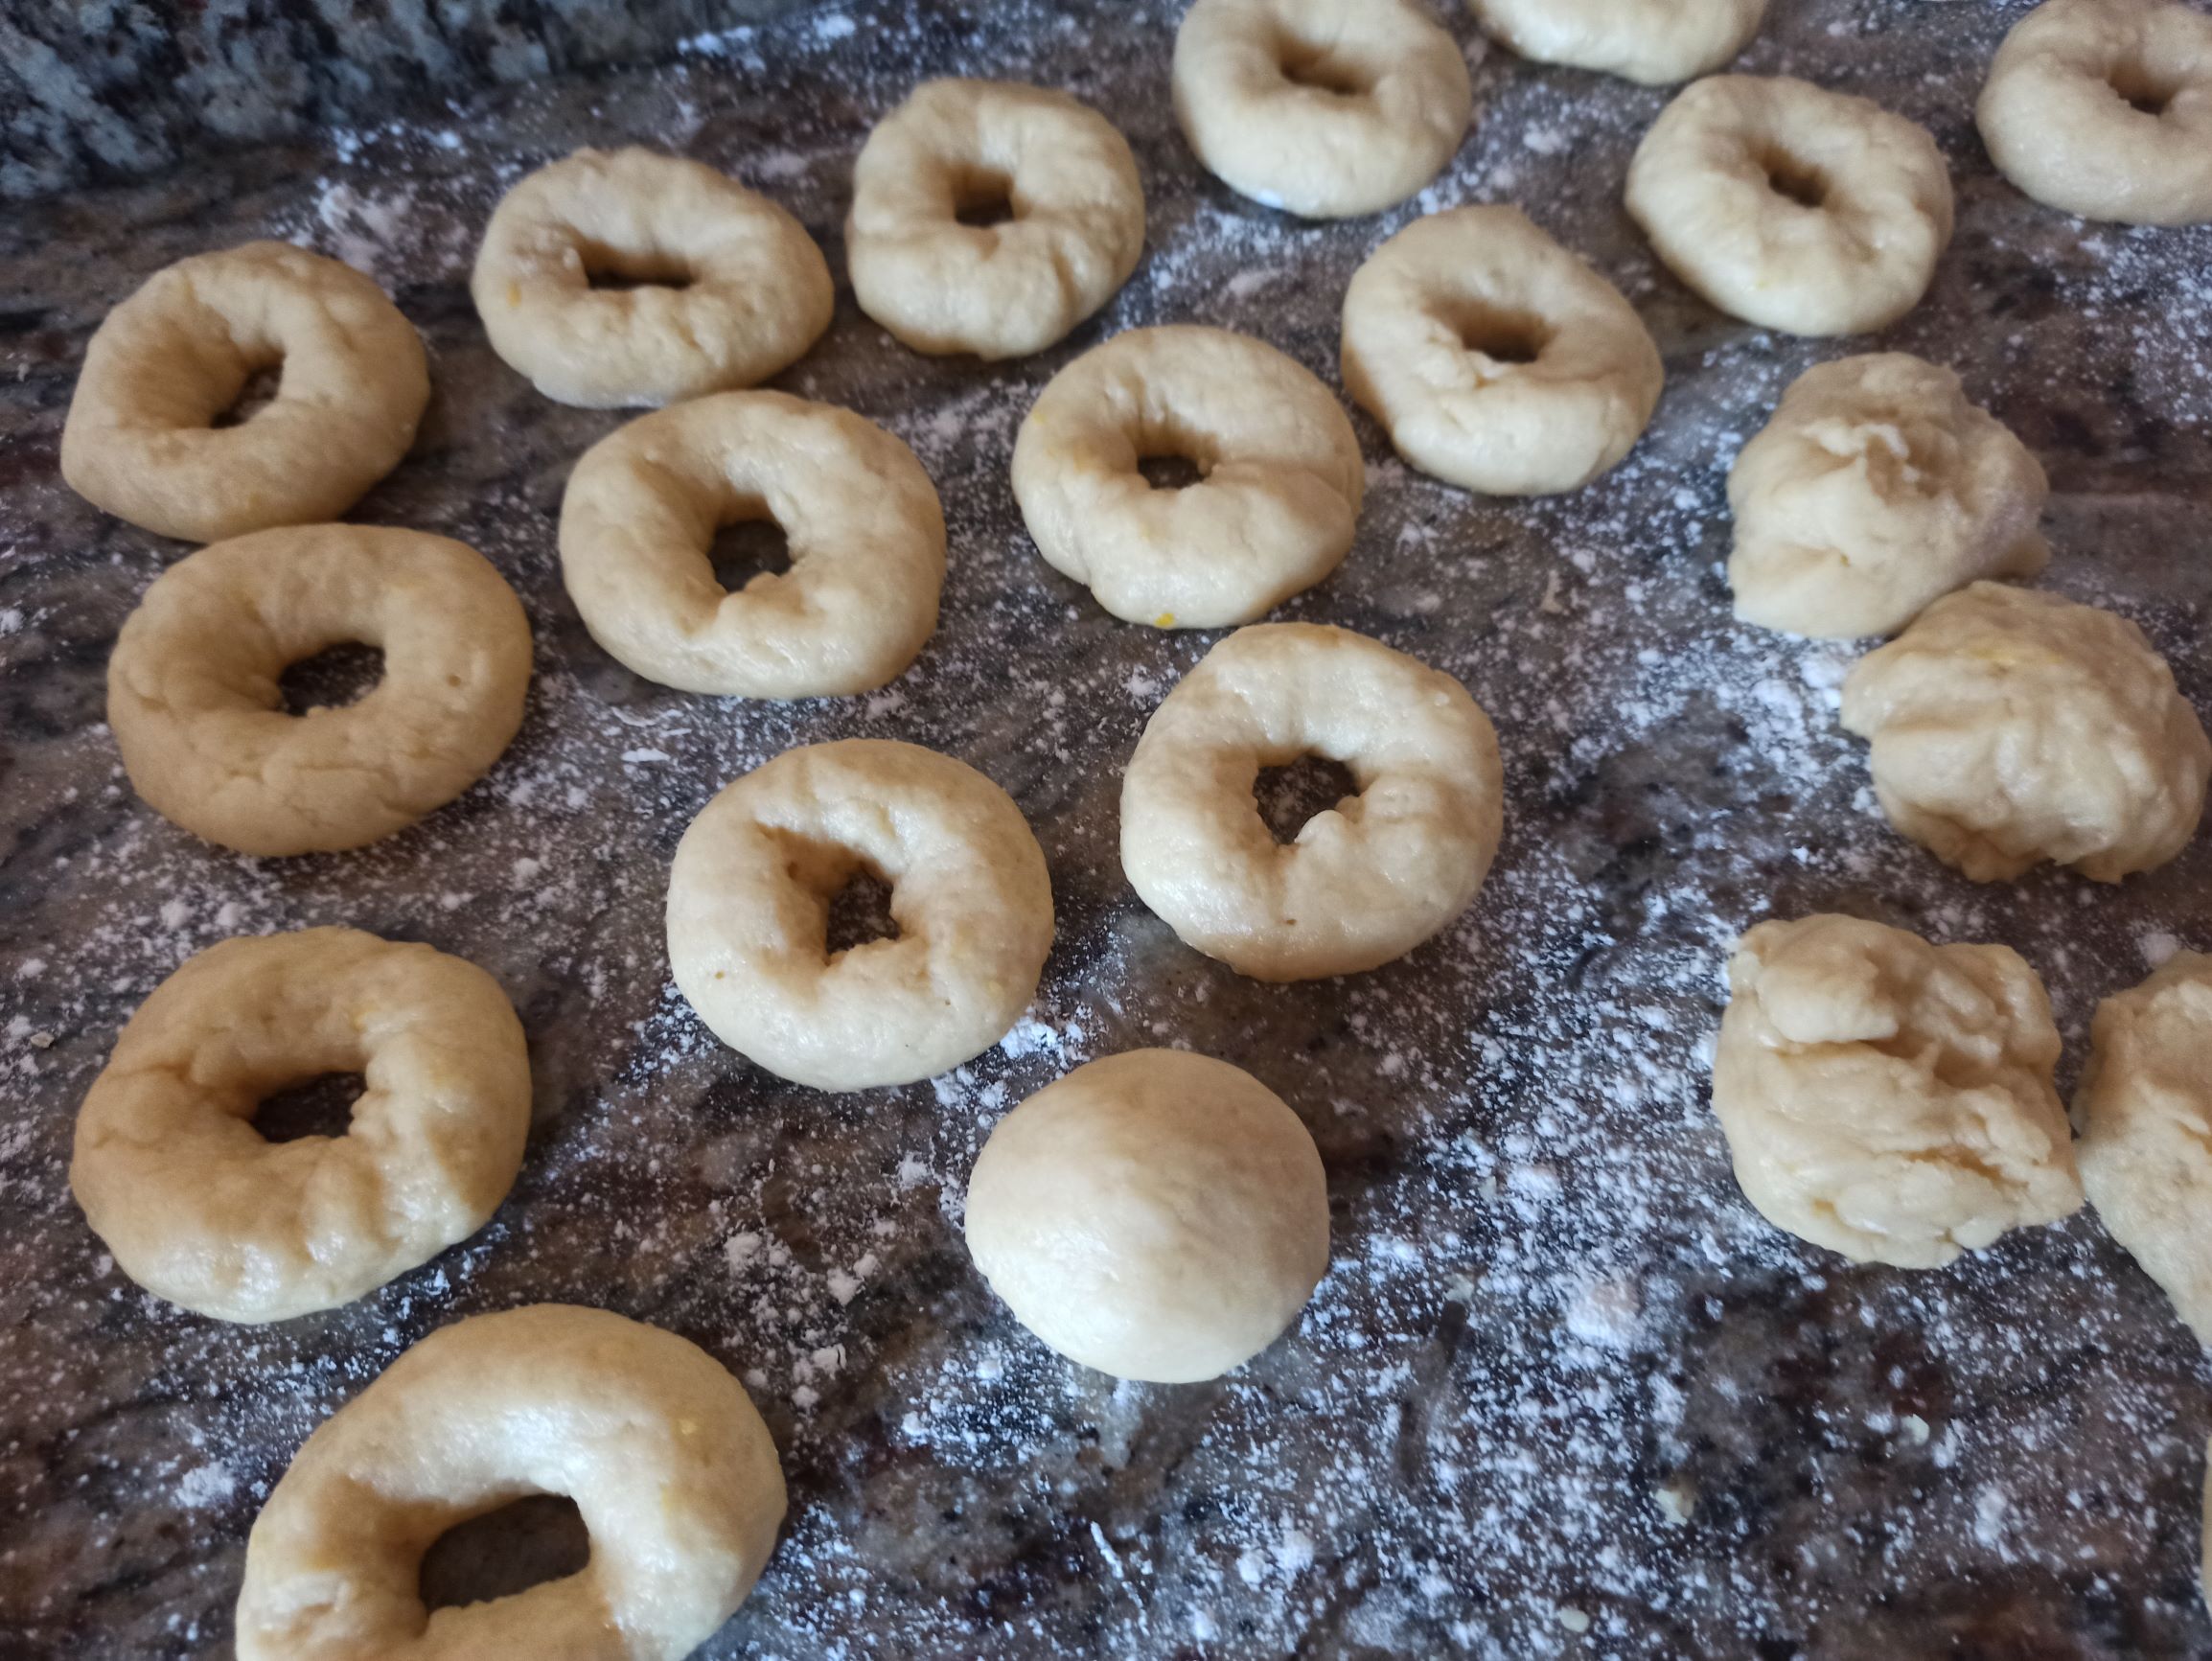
left=237, top=1303, right=785, bottom=1661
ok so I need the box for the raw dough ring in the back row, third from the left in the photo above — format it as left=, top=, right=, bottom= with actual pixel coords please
left=845, top=80, right=1143, bottom=358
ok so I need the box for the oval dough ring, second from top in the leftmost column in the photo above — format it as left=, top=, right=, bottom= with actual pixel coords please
left=108, top=524, right=531, bottom=856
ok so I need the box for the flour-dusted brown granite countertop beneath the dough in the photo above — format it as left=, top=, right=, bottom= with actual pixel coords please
left=0, top=0, right=2212, bottom=1661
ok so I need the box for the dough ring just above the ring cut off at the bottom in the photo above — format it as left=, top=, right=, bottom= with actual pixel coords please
left=69, top=929, right=531, bottom=1321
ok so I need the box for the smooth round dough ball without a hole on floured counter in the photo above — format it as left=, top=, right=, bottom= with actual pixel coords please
left=967, top=1050, right=1329, bottom=1385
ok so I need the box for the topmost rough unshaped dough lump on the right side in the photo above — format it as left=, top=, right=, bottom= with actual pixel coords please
left=1728, top=352, right=2051, bottom=639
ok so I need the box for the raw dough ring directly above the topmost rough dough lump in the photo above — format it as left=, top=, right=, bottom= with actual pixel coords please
left=1628, top=75, right=1951, bottom=336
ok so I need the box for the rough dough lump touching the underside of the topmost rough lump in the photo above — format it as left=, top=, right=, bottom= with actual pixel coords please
left=1843, top=582, right=2212, bottom=883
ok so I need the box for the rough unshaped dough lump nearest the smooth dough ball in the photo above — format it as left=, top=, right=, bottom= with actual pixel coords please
left=1712, top=915, right=2082, bottom=1270
